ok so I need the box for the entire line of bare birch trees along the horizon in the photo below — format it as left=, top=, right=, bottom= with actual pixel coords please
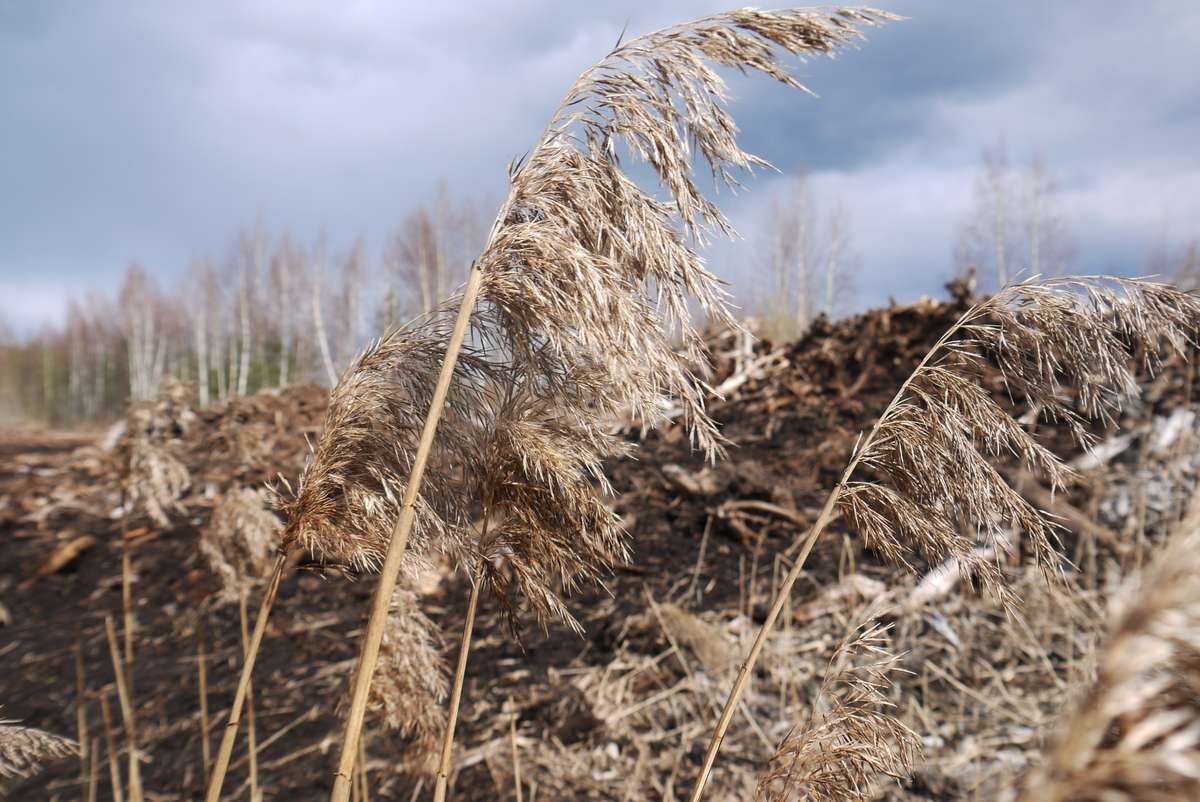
left=0, top=142, right=1200, bottom=425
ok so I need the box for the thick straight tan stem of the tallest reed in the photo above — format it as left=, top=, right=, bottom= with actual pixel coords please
left=328, top=265, right=482, bottom=802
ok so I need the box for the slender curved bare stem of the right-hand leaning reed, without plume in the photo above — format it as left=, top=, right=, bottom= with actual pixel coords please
left=689, top=307, right=977, bottom=802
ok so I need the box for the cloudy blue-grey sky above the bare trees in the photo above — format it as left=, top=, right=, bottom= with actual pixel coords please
left=0, top=0, right=1200, bottom=331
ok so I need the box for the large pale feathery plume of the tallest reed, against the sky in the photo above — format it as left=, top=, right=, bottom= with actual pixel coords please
left=478, top=10, right=892, bottom=454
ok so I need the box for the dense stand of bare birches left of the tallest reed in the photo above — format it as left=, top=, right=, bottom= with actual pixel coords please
left=0, top=191, right=485, bottom=425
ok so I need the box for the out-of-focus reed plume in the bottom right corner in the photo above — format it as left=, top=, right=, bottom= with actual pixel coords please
left=1020, top=499, right=1200, bottom=802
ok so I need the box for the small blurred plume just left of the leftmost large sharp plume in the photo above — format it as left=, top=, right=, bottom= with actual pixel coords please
left=199, top=487, right=281, bottom=603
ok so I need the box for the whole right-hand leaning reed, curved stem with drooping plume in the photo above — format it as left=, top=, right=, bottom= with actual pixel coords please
left=690, top=277, right=1200, bottom=802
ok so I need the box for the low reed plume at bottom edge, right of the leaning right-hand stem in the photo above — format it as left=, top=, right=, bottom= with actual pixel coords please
left=755, top=620, right=920, bottom=802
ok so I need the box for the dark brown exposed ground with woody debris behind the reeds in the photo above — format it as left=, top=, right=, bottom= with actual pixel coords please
left=0, top=291, right=1196, bottom=802
